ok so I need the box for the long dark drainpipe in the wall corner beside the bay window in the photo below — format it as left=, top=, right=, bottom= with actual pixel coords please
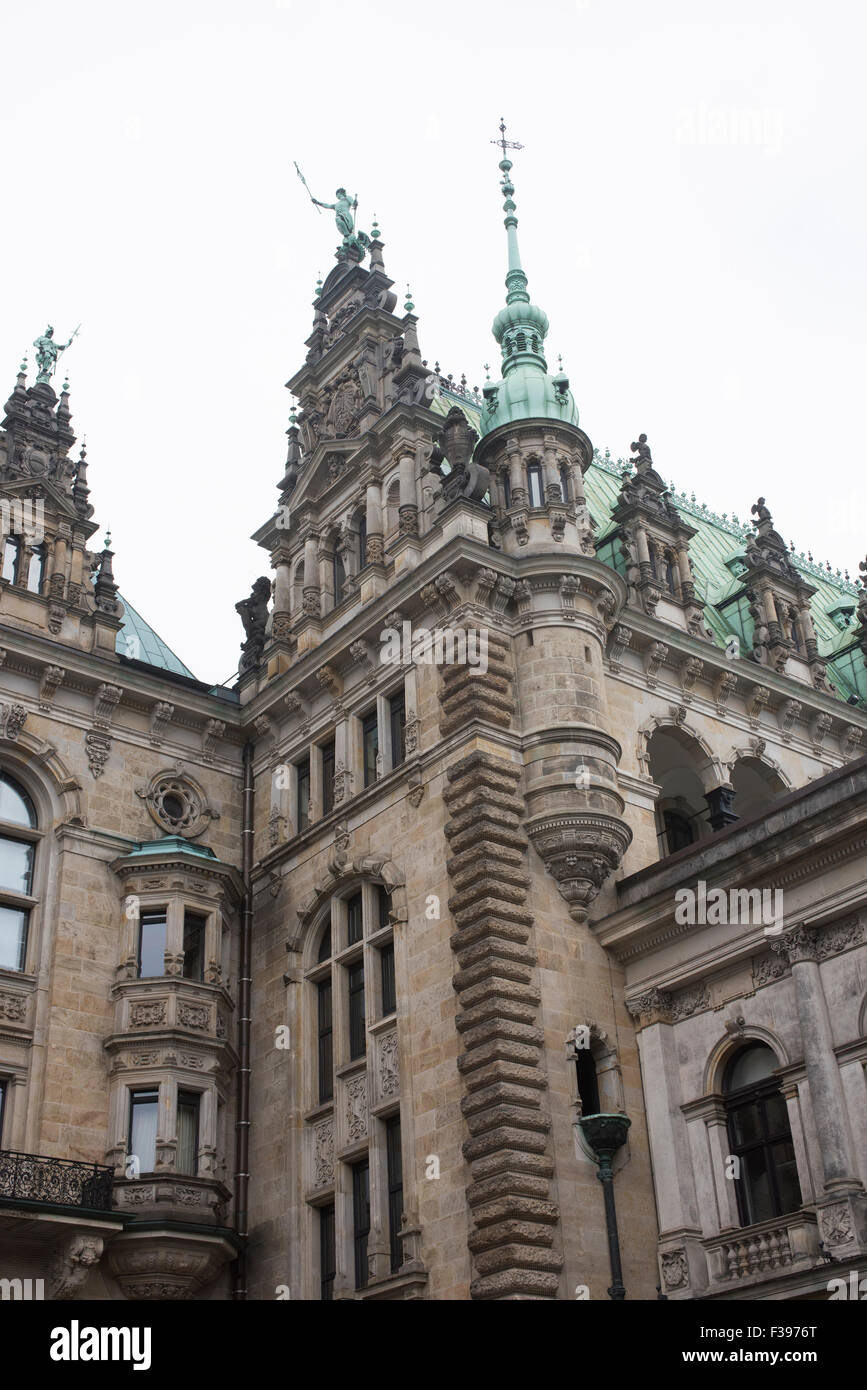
left=232, top=742, right=253, bottom=1300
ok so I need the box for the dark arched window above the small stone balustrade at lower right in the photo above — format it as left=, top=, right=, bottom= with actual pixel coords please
left=723, top=1043, right=800, bottom=1226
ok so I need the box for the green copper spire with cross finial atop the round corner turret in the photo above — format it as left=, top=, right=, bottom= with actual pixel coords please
left=481, top=120, right=578, bottom=435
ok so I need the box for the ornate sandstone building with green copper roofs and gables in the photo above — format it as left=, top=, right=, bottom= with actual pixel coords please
left=0, top=158, right=867, bottom=1300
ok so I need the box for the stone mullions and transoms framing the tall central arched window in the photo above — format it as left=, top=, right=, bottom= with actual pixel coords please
left=300, top=873, right=407, bottom=1300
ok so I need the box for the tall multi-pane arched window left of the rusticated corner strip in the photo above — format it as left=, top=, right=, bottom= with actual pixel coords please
left=306, top=880, right=403, bottom=1301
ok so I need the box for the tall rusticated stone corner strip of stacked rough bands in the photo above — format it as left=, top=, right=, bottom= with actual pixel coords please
left=443, top=750, right=563, bottom=1300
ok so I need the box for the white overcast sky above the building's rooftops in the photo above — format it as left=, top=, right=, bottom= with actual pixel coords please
left=0, top=0, right=867, bottom=681
